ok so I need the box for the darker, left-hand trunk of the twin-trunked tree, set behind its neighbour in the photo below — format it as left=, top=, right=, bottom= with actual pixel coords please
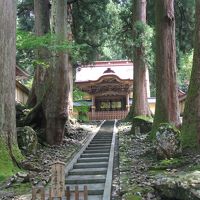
left=26, top=0, right=50, bottom=128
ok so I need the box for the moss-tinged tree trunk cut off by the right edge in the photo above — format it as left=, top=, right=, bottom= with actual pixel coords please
left=181, top=0, right=200, bottom=148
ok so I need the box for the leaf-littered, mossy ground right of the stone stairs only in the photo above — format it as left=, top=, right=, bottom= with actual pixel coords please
left=116, top=122, right=200, bottom=200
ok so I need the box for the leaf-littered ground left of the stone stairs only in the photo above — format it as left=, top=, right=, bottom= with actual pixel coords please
left=0, top=122, right=100, bottom=200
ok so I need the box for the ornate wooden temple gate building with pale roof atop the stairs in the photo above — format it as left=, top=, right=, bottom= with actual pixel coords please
left=75, top=60, right=152, bottom=120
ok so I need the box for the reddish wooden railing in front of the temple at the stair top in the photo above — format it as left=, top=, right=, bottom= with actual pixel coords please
left=88, top=110, right=128, bottom=120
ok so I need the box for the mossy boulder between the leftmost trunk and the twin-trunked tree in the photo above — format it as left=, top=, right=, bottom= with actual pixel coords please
left=17, top=126, right=38, bottom=154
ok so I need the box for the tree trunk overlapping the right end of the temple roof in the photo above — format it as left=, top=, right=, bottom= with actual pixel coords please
left=133, top=0, right=151, bottom=116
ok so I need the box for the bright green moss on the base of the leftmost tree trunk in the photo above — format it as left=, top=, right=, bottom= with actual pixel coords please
left=0, top=138, right=23, bottom=181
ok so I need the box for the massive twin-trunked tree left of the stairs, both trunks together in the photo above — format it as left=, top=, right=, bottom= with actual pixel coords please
left=27, top=0, right=70, bottom=145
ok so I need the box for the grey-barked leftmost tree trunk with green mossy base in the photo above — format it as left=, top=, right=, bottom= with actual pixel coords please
left=0, top=0, right=21, bottom=178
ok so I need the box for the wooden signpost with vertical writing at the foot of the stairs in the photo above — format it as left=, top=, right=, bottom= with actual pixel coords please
left=50, top=161, right=65, bottom=199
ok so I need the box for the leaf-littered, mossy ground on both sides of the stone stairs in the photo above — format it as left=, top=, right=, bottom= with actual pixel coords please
left=0, top=122, right=200, bottom=200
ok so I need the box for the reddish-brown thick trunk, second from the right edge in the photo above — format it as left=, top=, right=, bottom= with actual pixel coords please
left=153, top=0, right=180, bottom=132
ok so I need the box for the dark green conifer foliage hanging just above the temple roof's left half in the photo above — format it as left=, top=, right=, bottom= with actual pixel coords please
left=72, top=0, right=111, bottom=62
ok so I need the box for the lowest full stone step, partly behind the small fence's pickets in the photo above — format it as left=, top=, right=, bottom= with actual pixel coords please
left=66, top=183, right=105, bottom=196
